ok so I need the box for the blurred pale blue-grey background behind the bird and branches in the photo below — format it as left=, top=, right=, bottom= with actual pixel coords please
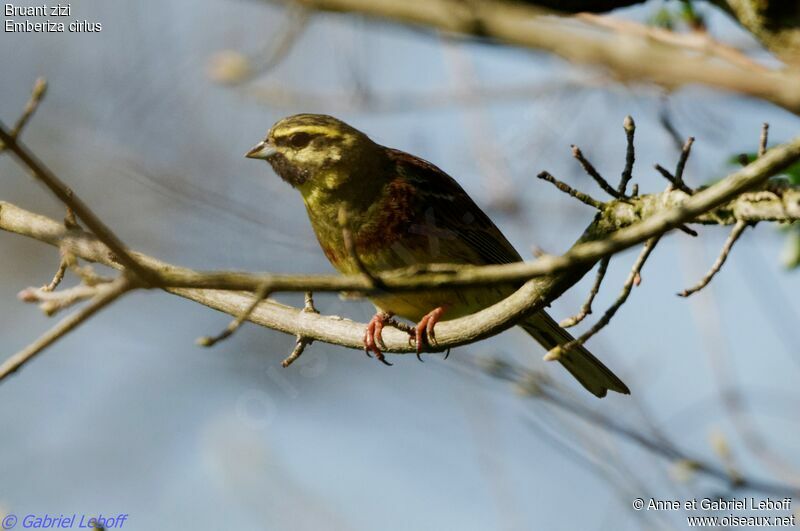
left=0, top=0, right=800, bottom=530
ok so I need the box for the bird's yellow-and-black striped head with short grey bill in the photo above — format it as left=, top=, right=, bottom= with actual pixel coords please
left=245, top=114, right=382, bottom=195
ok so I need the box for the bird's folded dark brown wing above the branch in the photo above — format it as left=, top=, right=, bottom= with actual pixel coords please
left=387, top=149, right=522, bottom=265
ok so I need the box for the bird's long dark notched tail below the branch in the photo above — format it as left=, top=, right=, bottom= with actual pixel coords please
left=520, top=311, right=631, bottom=398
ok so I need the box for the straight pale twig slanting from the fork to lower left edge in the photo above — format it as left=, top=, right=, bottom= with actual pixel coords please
left=0, top=275, right=135, bottom=381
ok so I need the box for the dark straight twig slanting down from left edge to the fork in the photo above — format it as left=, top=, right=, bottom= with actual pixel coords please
left=0, top=122, right=158, bottom=285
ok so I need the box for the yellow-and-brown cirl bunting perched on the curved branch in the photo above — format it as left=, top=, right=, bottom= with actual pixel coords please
left=246, top=114, right=630, bottom=397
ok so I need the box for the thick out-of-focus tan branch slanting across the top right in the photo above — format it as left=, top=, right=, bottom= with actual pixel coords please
left=271, top=0, right=800, bottom=114
